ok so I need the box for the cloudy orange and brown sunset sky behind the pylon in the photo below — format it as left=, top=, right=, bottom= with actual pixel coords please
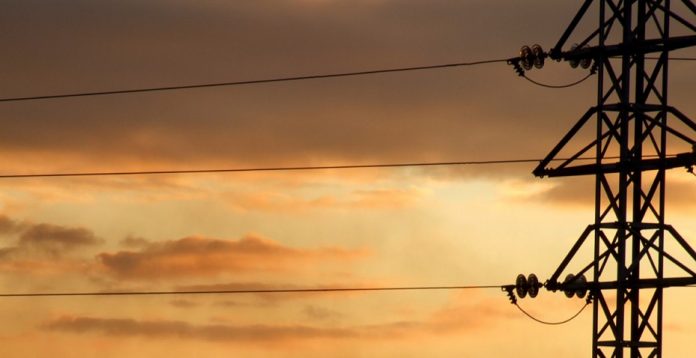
left=0, top=0, right=696, bottom=358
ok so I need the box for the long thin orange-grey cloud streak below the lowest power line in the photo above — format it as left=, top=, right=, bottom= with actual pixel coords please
left=42, top=297, right=519, bottom=344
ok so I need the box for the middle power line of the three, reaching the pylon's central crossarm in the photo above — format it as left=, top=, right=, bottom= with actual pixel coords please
left=0, top=155, right=673, bottom=179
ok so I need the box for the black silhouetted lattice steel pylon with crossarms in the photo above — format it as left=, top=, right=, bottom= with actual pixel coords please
left=534, top=0, right=696, bottom=357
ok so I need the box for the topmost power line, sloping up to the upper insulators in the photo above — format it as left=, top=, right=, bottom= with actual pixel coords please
left=0, top=59, right=507, bottom=102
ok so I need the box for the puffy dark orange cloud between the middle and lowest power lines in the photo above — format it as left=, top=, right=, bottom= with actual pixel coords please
left=97, top=236, right=366, bottom=279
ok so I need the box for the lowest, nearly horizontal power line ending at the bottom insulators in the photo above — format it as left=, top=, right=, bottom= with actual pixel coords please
left=0, top=285, right=501, bottom=298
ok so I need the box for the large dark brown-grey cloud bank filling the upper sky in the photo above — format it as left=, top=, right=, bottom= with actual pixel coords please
left=0, top=0, right=696, bottom=179
